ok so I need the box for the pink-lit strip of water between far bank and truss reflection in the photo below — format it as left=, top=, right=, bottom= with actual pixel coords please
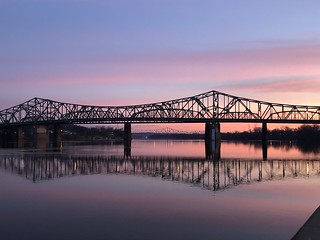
left=0, top=140, right=320, bottom=160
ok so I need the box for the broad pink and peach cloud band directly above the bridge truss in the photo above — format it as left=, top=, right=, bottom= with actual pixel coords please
left=0, top=44, right=320, bottom=108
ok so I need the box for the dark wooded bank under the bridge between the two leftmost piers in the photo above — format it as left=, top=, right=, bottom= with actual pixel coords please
left=63, top=124, right=123, bottom=140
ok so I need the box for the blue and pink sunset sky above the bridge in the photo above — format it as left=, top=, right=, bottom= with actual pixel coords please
left=0, top=0, right=320, bottom=129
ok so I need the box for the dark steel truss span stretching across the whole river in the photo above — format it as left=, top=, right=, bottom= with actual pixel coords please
left=0, top=90, right=320, bottom=126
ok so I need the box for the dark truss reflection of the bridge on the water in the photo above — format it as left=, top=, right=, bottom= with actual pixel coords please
left=0, top=154, right=320, bottom=191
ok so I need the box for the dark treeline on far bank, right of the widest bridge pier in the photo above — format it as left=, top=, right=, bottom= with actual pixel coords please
left=221, top=125, right=320, bottom=142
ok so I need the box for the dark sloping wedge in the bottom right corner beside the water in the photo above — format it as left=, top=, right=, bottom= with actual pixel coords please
left=292, top=206, right=320, bottom=240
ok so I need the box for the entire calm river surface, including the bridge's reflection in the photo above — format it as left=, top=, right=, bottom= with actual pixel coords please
left=0, top=141, right=320, bottom=239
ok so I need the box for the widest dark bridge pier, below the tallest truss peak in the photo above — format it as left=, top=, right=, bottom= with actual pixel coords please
left=205, top=122, right=221, bottom=160
